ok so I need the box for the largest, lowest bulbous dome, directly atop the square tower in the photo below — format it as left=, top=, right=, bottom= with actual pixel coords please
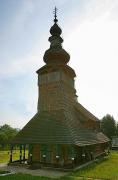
left=43, top=48, right=70, bottom=64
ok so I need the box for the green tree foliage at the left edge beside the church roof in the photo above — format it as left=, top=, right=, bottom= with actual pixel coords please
left=0, top=124, right=18, bottom=148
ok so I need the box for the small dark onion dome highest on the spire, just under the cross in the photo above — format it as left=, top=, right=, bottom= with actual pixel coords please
left=50, top=23, right=62, bottom=36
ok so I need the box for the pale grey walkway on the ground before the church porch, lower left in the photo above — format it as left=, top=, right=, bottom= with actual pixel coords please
left=0, top=164, right=69, bottom=178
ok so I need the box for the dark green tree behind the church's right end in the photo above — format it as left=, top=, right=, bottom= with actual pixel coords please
left=101, top=114, right=116, bottom=139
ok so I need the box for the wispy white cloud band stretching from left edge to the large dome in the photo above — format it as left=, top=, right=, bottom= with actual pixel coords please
left=0, top=43, right=44, bottom=77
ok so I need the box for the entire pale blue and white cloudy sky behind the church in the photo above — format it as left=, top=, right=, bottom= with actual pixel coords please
left=0, top=0, right=118, bottom=128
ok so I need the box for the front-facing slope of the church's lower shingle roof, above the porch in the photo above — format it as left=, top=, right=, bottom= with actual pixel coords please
left=13, top=111, right=73, bottom=144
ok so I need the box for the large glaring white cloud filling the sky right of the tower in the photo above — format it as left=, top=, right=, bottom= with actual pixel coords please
left=64, top=1, right=118, bottom=120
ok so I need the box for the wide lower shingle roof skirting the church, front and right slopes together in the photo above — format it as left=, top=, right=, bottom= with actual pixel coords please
left=12, top=110, right=108, bottom=146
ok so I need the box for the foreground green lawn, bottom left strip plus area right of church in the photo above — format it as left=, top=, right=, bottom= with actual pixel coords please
left=0, top=152, right=118, bottom=180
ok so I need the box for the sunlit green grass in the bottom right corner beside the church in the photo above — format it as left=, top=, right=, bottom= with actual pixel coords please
left=71, top=152, right=118, bottom=180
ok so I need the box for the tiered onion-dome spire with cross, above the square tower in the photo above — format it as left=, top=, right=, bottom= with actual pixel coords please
left=43, top=8, right=70, bottom=64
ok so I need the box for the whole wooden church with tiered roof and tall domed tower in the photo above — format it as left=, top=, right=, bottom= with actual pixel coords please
left=10, top=9, right=109, bottom=168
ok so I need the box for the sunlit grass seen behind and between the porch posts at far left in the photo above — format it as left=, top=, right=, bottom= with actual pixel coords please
left=0, top=150, right=28, bottom=163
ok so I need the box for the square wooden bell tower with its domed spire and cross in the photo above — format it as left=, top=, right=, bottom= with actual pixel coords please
left=37, top=7, right=77, bottom=111
